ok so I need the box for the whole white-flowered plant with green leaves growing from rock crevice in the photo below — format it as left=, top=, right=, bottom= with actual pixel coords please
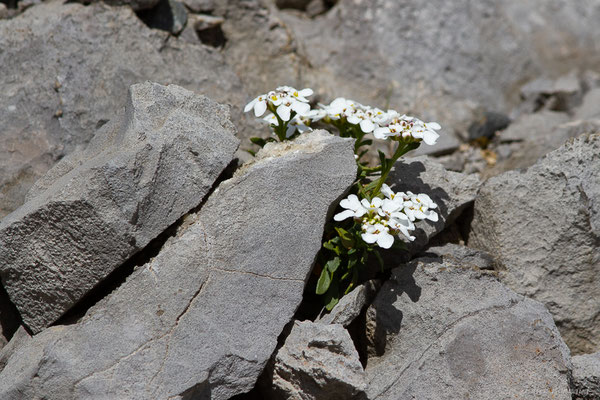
left=244, top=86, right=441, bottom=310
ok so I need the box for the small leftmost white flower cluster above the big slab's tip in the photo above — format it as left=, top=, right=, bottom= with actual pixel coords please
left=244, top=86, right=313, bottom=122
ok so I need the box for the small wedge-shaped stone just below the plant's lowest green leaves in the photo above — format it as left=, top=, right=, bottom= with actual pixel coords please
left=316, top=279, right=381, bottom=328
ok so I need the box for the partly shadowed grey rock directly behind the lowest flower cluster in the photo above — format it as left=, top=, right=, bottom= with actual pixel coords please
left=388, top=156, right=480, bottom=254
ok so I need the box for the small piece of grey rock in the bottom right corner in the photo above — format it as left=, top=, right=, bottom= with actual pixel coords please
left=571, top=353, right=600, bottom=400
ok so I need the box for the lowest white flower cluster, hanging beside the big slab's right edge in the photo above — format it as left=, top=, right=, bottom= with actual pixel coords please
left=333, top=184, right=438, bottom=249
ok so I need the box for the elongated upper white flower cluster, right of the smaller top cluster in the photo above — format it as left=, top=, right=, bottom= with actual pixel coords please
left=307, top=97, right=441, bottom=145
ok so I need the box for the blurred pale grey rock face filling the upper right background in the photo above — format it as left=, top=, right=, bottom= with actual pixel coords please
left=278, top=0, right=600, bottom=138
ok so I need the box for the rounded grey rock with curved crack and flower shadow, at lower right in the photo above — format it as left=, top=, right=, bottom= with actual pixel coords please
left=366, top=249, right=571, bottom=400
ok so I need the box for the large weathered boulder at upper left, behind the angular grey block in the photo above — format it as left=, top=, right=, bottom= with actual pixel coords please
left=0, top=1, right=246, bottom=218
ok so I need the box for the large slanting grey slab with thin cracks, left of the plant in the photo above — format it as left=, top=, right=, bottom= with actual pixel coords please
left=0, top=131, right=356, bottom=400
